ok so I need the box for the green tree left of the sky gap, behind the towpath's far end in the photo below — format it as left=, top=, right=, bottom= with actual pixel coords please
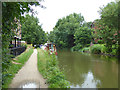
left=21, top=15, right=47, bottom=44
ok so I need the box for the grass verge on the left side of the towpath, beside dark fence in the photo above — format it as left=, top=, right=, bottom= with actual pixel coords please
left=2, top=47, right=33, bottom=88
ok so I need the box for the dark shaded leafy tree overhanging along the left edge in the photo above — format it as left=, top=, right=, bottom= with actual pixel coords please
left=2, top=2, right=40, bottom=84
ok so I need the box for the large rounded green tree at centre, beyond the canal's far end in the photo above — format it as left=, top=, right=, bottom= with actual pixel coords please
left=48, top=13, right=84, bottom=48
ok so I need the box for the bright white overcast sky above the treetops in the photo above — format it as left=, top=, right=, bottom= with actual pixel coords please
left=32, top=0, right=115, bottom=32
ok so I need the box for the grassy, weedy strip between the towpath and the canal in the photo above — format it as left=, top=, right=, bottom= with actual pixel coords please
left=37, top=48, right=70, bottom=88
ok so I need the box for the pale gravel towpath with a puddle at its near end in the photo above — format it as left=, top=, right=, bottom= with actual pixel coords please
left=10, top=49, right=48, bottom=88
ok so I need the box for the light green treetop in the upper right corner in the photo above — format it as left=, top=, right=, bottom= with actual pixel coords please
left=99, top=2, right=118, bottom=29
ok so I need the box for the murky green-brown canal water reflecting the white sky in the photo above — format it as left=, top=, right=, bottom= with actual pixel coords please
left=58, top=50, right=118, bottom=88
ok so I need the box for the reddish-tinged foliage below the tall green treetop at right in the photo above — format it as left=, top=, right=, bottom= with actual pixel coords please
left=96, top=24, right=117, bottom=52
